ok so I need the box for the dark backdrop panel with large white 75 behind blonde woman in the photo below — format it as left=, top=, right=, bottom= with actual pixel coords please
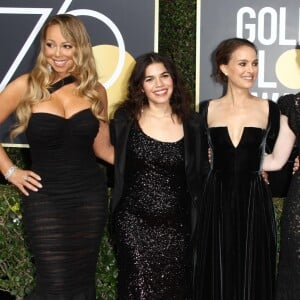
left=0, top=0, right=158, bottom=147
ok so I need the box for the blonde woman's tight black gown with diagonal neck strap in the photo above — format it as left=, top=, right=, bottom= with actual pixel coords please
left=22, top=77, right=107, bottom=300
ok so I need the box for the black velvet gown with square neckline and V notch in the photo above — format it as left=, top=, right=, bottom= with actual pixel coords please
left=195, top=101, right=279, bottom=300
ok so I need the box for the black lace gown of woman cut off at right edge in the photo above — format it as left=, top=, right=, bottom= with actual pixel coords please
left=276, top=93, right=300, bottom=300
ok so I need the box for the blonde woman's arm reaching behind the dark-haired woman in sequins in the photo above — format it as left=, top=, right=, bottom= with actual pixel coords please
left=94, top=86, right=114, bottom=164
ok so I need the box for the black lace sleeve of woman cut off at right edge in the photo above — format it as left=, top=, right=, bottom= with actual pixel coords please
left=278, top=94, right=300, bottom=135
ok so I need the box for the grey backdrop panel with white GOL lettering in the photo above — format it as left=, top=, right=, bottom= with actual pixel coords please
left=197, top=0, right=300, bottom=108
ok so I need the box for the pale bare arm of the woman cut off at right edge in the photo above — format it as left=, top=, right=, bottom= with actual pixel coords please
left=263, top=115, right=296, bottom=171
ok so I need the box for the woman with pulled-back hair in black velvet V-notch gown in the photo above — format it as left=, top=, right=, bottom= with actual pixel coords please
left=195, top=38, right=279, bottom=300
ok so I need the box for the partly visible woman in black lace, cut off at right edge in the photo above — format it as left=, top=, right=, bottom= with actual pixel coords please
left=263, top=93, right=300, bottom=300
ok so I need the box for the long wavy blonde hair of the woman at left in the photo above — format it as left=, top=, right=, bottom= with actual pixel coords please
left=11, top=14, right=104, bottom=137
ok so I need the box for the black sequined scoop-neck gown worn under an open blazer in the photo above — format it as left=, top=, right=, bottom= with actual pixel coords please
left=114, top=125, right=191, bottom=300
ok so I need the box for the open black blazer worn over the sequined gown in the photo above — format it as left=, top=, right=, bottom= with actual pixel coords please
left=110, top=109, right=207, bottom=239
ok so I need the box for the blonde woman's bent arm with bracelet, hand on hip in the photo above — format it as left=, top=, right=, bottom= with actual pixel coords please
left=0, top=75, right=42, bottom=196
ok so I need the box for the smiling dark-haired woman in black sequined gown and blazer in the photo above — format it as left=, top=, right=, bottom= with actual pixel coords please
left=111, top=53, right=201, bottom=300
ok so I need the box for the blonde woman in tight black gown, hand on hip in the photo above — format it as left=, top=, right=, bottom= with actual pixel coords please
left=0, top=14, right=113, bottom=300
